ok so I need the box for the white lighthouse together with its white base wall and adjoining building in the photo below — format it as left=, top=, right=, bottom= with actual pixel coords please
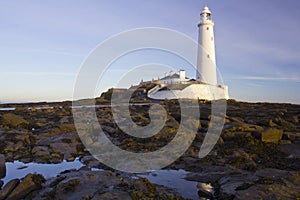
left=147, top=6, right=229, bottom=100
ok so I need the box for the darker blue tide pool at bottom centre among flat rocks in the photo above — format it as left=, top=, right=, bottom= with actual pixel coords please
left=138, top=169, right=199, bottom=199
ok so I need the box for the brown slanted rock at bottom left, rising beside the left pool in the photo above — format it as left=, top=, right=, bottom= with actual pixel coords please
left=7, top=174, right=45, bottom=200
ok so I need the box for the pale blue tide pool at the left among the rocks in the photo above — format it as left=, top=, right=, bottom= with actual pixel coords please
left=2, top=159, right=84, bottom=183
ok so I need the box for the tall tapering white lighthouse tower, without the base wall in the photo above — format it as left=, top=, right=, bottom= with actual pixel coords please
left=196, top=6, right=218, bottom=85
